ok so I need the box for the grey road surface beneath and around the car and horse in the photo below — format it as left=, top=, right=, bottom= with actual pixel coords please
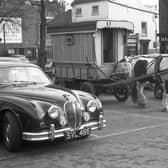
left=0, top=91, right=168, bottom=168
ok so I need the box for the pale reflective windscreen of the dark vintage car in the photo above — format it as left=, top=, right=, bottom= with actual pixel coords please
left=0, top=66, right=51, bottom=84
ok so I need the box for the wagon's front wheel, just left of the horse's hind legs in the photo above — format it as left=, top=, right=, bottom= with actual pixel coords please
left=114, top=85, right=129, bottom=102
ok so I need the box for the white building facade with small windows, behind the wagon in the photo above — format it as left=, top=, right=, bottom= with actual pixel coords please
left=72, top=0, right=158, bottom=54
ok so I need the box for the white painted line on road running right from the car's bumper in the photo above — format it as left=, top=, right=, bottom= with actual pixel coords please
left=92, top=123, right=168, bottom=140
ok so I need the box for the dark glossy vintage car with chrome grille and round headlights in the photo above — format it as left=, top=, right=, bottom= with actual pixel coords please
left=0, top=61, right=106, bottom=151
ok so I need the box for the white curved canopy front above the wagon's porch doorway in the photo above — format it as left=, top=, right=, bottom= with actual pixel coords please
left=96, top=20, right=134, bottom=31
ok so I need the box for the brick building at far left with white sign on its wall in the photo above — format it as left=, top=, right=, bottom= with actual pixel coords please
left=0, top=6, right=40, bottom=59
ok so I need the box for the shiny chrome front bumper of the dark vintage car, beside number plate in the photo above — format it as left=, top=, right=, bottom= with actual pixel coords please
left=22, top=119, right=106, bottom=141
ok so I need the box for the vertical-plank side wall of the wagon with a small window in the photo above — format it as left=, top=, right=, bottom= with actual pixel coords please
left=51, top=33, right=95, bottom=63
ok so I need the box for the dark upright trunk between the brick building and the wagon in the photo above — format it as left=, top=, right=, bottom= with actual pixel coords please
left=37, top=0, right=46, bottom=69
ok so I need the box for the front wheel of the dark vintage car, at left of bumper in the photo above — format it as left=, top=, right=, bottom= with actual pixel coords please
left=3, top=112, right=22, bottom=152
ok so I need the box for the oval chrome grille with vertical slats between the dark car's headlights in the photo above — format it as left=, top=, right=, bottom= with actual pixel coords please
left=64, top=101, right=82, bottom=129
